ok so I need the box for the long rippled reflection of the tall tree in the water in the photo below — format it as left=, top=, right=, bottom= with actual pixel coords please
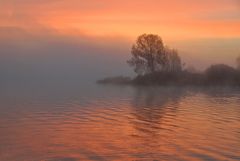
left=132, top=87, right=183, bottom=134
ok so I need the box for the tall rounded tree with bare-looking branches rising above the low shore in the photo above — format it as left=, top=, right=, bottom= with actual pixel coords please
left=127, top=34, right=182, bottom=74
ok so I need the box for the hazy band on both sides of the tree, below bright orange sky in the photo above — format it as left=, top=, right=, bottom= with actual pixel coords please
left=0, top=27, right=240, bottom=92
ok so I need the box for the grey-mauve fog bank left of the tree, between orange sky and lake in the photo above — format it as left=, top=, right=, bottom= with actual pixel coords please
left=0, top=28, right=132, bottom=91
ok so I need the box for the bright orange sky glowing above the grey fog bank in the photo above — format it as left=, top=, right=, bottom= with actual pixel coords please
left=0, top=0, right=240, bottom=39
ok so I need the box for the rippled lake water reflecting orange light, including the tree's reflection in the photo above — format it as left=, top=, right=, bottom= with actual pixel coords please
left=0, top=84, right=240, bottom=161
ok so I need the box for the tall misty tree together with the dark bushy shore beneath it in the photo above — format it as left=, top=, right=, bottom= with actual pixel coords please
left=98, top=34, right=240, bottom=86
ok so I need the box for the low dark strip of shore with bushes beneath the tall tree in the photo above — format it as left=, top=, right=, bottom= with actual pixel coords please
left=97, top=65, right=240, bottom=86
